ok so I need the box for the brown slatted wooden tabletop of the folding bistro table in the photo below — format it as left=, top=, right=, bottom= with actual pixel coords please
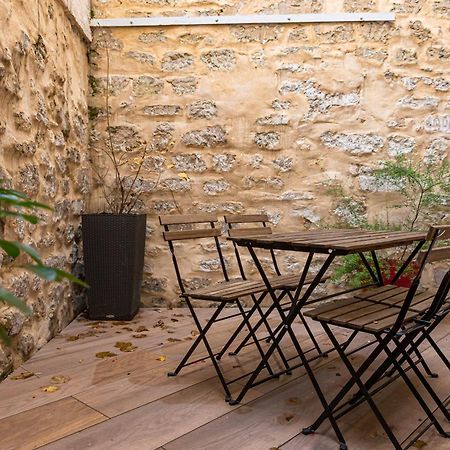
left=228, top=230, right=426, bottom=255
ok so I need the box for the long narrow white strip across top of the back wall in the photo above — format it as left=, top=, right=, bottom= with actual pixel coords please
left=91, top=12, right=395, bottom=27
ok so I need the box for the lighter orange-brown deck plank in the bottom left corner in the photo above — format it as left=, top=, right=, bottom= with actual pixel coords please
left=0, top=398, right=107, bottom=450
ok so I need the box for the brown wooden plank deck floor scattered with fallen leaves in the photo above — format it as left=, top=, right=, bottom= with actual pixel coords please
left=0, top=309, right=450, bottom=450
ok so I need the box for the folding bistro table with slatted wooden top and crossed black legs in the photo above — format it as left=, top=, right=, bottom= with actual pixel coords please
left=228, top=230, right=426, bottom=404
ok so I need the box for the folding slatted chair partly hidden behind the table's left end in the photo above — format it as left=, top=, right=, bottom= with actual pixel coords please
left=220, top=214, right=328, bottom=356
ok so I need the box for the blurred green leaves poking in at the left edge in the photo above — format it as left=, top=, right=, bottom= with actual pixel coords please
left=0, top=180, right=87, bottom=344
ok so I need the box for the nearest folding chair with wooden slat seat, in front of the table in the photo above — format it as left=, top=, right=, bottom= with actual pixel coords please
left=302, top=226, right=450, bottom=449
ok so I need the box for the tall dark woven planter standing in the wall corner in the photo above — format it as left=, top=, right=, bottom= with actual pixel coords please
left=82, top=214, right=147, bottom=320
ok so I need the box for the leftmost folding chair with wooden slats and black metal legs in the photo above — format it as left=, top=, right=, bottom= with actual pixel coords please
left=159, top=214, right=289, bottom=401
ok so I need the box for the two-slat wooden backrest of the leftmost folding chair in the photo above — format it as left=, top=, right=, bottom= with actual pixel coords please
left=159, top=214, right=229, bottom=294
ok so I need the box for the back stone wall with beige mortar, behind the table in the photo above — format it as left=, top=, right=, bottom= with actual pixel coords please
left=90, top=0, right=450, bottom=304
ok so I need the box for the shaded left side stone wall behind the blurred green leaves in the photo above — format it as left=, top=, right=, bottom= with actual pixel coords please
left=0, top=0, right=91, bottom=377
